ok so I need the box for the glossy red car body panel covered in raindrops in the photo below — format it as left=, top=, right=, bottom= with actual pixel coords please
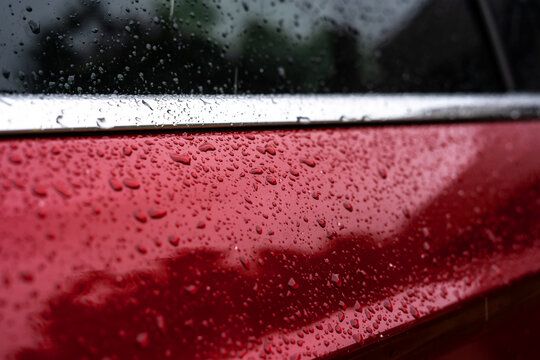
left=0, top=122, right=540, bottom=359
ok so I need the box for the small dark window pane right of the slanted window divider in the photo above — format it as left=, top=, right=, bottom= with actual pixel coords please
left=490, top=0, right=540, bottom=91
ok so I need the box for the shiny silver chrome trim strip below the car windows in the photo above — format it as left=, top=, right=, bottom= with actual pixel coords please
left=0, top=93, right=540, bottom=134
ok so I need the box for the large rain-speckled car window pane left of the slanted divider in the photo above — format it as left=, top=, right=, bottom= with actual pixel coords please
left=0, top=0, right=501, bottom=94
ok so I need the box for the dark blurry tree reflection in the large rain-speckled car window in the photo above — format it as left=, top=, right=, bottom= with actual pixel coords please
left=17, top=2, right=372, bottom=93
